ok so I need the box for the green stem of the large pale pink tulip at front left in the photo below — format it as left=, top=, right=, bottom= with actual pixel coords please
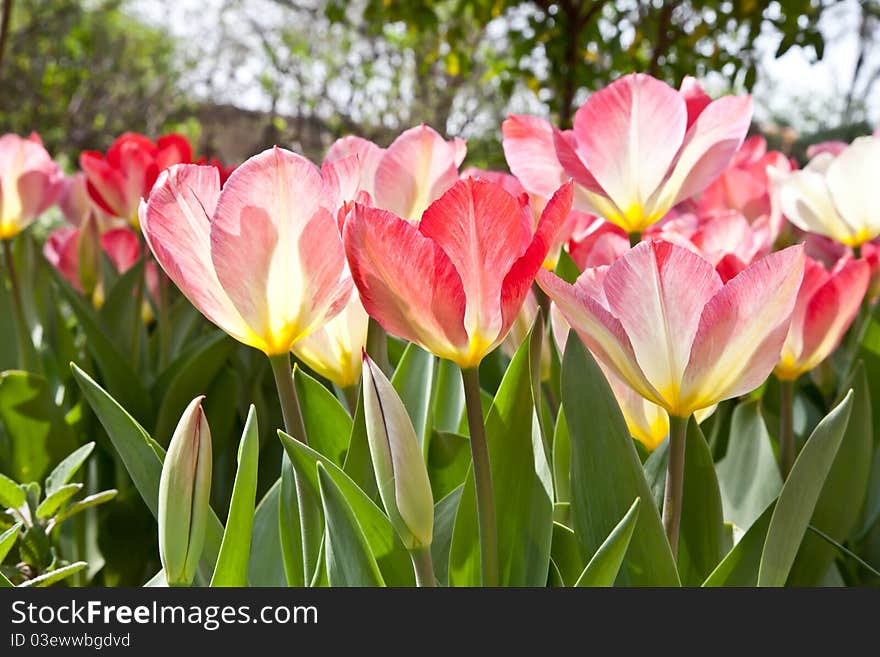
left=269, top=353, right=321, bottom=586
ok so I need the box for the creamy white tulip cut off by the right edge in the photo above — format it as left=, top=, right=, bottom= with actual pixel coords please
left=770, top=137, right=880, bottom=247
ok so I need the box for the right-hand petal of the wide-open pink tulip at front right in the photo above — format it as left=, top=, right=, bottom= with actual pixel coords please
left=675, top=245, right=804, bottom=415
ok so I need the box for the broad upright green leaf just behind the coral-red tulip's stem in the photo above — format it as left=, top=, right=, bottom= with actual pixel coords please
left=449, top=332, right=553, bottom=586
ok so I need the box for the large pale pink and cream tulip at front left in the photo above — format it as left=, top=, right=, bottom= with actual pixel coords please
left=140, top=147, right=352, bottom=356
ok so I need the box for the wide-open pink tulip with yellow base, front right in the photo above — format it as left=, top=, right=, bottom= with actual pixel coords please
left=537, top=240, right=804, bottom=417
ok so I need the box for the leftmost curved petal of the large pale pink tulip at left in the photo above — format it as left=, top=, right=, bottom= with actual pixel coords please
left=140, top=164, right=262, bottom=348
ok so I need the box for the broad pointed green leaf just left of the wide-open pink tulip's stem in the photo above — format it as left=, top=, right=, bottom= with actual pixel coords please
left=562, top=333, right=679, bottom=586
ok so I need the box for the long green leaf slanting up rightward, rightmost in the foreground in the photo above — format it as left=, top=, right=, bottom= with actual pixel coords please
left=758, top=390, right=853, bottom=586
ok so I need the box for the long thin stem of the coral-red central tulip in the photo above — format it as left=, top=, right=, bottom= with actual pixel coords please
left=461, top=367, right=498, bottom=586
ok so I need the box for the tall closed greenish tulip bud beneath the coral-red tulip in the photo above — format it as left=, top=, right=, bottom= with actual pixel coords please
left=363, top=354, right=434, bottom=550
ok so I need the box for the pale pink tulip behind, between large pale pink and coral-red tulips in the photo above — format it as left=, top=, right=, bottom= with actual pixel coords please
left=324, top=124, right=467, bottom=221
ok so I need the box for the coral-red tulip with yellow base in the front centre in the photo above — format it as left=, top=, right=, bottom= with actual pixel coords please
left=344, top=178, right=572, bottom=369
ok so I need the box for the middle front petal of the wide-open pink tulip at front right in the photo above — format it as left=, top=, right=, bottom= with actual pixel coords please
left=603, top=241, right=722, bottom=408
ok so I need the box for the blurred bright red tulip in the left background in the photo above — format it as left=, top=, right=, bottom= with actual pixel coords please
left=79, top=132, right=192, bottom=227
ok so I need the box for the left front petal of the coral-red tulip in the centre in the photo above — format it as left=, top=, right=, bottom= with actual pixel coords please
left=344, top=203, right=468, bottom=361
